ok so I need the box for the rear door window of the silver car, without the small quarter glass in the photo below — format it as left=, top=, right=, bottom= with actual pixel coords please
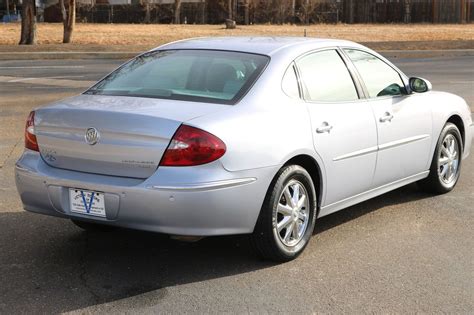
left=297, top=50, right=359, bottom=102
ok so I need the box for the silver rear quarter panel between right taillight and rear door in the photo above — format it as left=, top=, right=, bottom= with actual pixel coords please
left=187, top=60, right=317, bottom=171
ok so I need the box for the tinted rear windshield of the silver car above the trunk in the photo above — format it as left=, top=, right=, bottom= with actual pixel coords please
left=85, top=50, right=269, bottom=104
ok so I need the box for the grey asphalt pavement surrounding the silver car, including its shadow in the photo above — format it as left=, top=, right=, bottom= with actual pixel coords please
left=0, top=57, right=474, bottom=314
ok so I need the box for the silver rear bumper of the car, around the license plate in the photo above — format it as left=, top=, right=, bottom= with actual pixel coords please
left=15, top=150, right=277, bottom=236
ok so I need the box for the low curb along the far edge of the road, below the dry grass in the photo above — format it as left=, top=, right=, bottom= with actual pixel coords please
left=0, top=49, right=474, bottom=60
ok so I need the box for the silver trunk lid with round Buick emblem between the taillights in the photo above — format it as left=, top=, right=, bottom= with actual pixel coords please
left=35, top=95, right=227, bottom=178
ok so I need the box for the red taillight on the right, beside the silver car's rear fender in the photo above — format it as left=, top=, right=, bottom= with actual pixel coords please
left=160, top=125, right=226, bottom=166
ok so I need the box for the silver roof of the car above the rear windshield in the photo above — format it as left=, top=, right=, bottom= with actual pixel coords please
left=153, top=36, right=362, bottom=56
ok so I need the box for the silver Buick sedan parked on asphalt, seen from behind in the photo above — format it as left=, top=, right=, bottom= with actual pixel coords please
left=15, top=37, right=474, bottom=261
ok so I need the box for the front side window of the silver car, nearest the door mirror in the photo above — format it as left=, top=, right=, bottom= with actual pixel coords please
left=345, top=49, right=405, bottom=98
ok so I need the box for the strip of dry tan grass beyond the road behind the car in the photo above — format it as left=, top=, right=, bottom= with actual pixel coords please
left=0, top=23, right=474, bottom=47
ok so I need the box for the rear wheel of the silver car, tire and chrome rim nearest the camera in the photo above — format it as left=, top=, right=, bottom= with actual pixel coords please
left=251, top=165, right=316, bottom=262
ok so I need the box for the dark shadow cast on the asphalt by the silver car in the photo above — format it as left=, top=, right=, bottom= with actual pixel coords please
left=0, top=186, right=429, bottom=313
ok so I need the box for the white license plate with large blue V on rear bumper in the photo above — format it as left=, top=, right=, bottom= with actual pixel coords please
left=69, top=188, right=105, bottom=218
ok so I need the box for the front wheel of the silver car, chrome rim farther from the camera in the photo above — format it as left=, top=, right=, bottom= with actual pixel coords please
left=418, top=123, right=463, bottom=194
